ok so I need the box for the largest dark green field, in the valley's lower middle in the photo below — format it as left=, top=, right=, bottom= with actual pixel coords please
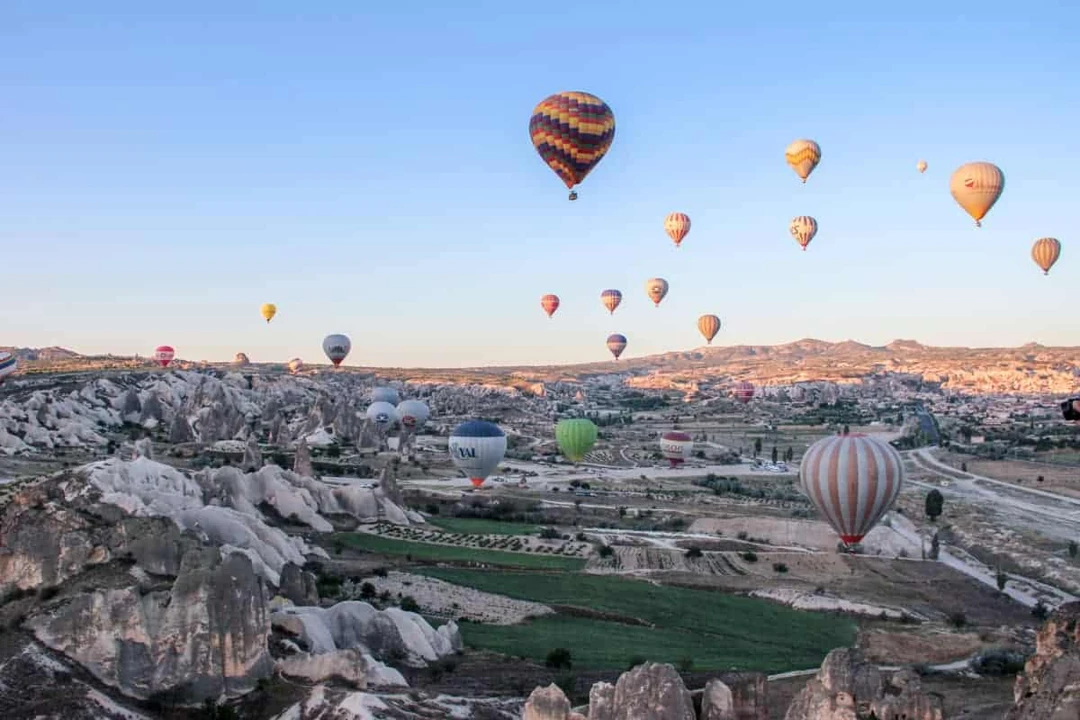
left=421, top=568, right=855, bottom=671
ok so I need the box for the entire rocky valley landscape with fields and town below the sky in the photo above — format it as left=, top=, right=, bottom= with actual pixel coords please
left=0, top=339, right=1080, bottom=720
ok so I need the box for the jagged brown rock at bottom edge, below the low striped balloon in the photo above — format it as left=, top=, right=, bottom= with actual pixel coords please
left=784, top=648, right=945, bottom=720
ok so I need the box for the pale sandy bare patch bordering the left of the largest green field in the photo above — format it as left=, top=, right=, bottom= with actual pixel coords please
left=362, top=572, right=554, bottom=625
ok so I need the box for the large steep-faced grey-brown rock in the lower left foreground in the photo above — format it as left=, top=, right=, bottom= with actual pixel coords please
left=26, top=547, right=273, bottom=703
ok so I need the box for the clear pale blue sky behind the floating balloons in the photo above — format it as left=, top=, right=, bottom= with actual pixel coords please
left=0, top=0, right=1080, bottom=366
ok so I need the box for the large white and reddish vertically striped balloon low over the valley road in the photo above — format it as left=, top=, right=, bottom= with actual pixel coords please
left=799, top=433, right=904, bottom=545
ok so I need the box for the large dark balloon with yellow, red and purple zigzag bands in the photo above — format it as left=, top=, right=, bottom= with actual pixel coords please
left=529, top=93, right=615, bottom=200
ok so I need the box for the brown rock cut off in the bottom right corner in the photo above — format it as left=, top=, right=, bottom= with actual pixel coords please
left=1005, top=602, right=1080, bottom=720
